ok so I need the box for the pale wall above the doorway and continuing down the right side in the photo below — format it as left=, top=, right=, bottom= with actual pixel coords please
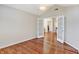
left=40, top=6, right=79, bottom=50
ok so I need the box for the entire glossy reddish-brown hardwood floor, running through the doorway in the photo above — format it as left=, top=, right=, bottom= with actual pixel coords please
left=0, top=33, right=78, bottom=54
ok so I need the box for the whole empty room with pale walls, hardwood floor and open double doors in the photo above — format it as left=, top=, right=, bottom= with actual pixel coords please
left=0, top=4, right=79, bottom=54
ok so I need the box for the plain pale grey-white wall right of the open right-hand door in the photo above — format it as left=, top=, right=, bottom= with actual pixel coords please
left=64, top=6, right=79, bottom=50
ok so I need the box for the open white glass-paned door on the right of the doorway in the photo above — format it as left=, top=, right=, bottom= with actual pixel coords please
left=57, top=16, right=64, bottom=43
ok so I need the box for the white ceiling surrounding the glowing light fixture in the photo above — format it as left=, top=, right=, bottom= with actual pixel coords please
left=6, top=4, right=78, bottom=15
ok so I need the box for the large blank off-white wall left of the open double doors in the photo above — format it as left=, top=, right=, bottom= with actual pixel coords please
left=0, top=5, right=37, bottom=48
